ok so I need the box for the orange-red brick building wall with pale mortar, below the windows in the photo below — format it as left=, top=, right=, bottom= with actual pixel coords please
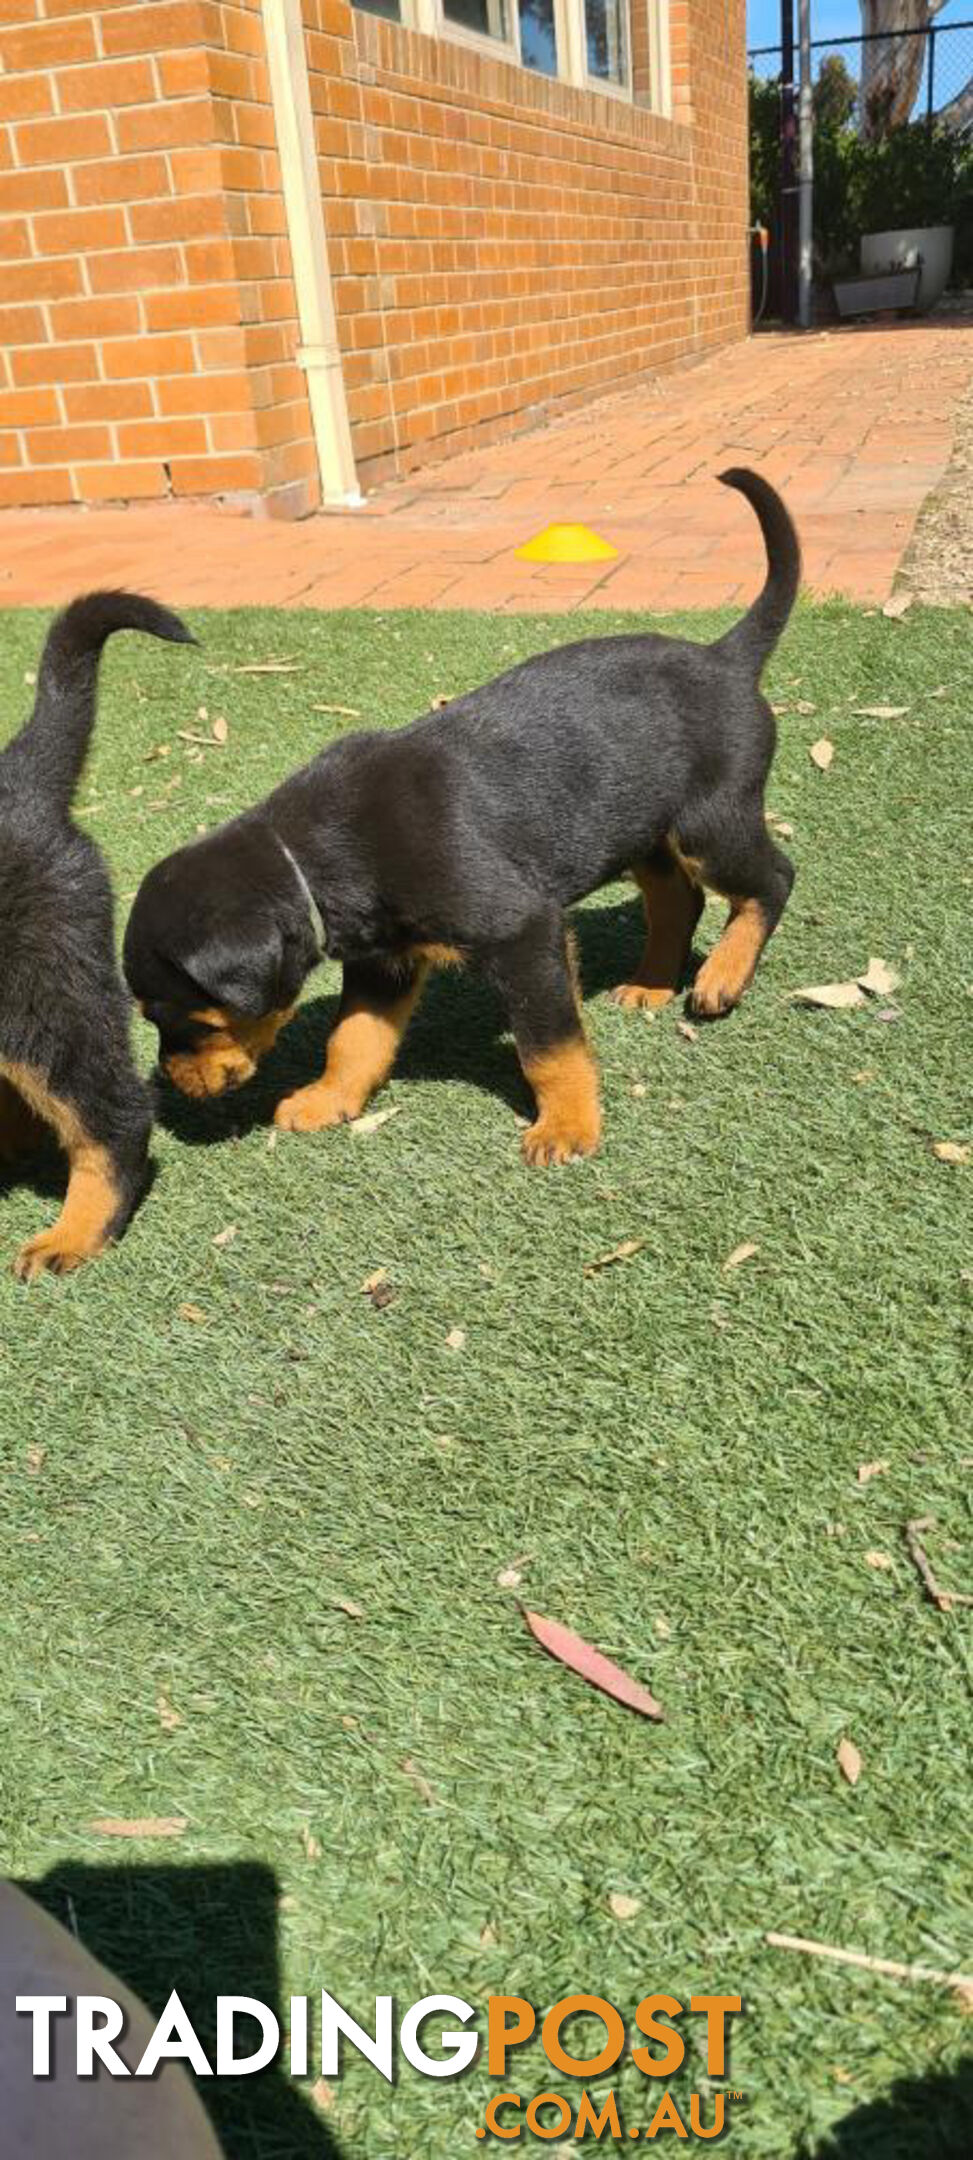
left=0, top=0, right=746, bottom=514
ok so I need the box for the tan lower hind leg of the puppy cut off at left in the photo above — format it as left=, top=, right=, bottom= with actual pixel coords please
left=2, top=1065, right=121, bottom=1283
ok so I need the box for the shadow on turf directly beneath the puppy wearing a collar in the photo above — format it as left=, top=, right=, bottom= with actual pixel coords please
left=158, top=901, right=704, bottom=1147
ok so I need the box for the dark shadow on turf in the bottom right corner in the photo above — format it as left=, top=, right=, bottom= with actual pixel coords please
left=794, top=2056, right=973, bottom=2160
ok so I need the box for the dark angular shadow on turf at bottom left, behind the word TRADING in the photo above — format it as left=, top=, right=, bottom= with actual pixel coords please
left=19, top=1862, right=339, bottom=2160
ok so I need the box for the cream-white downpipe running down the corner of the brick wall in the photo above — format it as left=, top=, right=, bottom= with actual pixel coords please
left=262, top=0, right=361, bottom=508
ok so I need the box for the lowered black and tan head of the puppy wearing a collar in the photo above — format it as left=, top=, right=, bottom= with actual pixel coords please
left=123, top=821, right=320, bottom=1099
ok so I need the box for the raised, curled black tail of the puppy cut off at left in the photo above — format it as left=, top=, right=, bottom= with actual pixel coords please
left=17, top=592, right=197, bottom=810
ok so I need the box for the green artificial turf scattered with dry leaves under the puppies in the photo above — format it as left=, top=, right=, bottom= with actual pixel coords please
left=0, top=605, right=973, bottom=2160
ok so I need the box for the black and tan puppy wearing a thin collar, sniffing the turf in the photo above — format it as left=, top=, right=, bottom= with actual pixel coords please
left=125, top=471, right=800, bottom=1162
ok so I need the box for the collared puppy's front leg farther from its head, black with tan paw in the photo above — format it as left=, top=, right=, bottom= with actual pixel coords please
left=487, top=907, right=601, bottom=1164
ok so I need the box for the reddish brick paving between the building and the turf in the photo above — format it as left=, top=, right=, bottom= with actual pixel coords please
left=0, top=318, right=973, bottom=613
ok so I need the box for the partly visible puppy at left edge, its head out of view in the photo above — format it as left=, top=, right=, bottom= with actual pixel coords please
left=0, top=592, right=190, bottom=1281
